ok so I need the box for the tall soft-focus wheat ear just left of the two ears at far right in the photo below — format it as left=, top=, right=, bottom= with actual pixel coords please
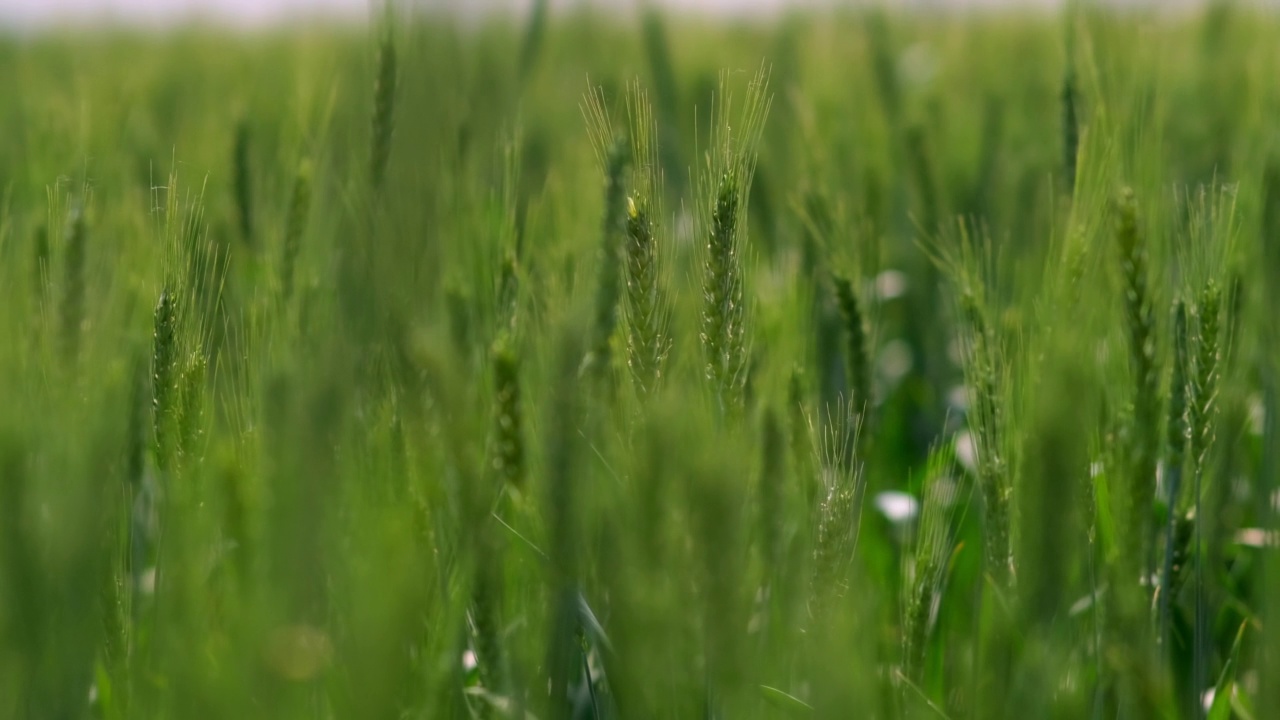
left=1115, top=188, right=1160, bottom=575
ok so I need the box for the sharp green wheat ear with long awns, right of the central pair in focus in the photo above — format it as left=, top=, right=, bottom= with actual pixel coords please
left=696, top=68, right=771, bottom=410
